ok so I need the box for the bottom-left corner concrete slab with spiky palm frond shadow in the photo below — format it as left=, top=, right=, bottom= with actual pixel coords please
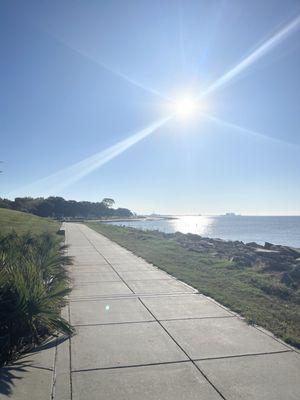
left=0, top=361, right=53, bottom=400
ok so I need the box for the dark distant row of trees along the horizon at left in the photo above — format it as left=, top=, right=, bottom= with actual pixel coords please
left=0, top=196, right=133, bottom=219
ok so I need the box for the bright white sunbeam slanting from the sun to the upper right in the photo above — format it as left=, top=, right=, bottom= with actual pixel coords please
left=199, top=15, right=300, bottom=98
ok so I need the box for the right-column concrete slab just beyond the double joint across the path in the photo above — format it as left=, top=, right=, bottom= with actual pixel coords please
left=127, top=279, right=196, bottom=294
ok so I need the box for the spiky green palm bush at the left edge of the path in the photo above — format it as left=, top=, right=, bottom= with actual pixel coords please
left=0, top=233, right=73, bottom=364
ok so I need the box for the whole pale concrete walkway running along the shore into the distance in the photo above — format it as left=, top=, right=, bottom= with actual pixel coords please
left=0, top=223, right=300, bottom=400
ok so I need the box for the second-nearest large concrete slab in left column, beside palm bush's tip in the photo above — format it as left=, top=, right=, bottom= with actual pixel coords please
left=71, top=322, right=187, bottom=371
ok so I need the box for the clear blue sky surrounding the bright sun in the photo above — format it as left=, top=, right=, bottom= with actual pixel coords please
left=0, top=0, right=300, bottom=215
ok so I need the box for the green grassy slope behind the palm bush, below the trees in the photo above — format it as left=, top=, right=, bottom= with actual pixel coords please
left=0, top=208, right=60, bottom=235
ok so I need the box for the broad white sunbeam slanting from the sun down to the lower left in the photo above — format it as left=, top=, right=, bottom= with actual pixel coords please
left=8, top=115, right=173, bottom=198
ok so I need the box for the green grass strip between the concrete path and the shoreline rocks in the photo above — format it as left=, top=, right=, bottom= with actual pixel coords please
left=87, top=222, right=300, bottom=348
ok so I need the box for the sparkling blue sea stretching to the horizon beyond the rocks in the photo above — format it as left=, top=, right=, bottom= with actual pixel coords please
left=106, top=215, right=300, bottom=248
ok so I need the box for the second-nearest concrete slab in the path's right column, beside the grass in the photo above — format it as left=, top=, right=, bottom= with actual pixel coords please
left=162, top=318, right=287, bottom=360
